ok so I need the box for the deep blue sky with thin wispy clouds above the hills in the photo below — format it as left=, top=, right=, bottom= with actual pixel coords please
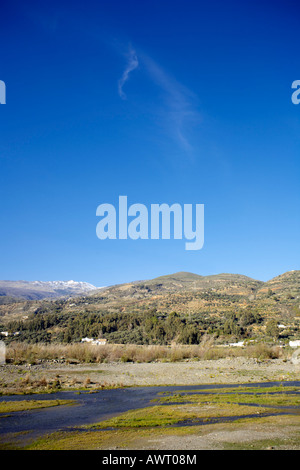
left=0, top=0, right=300, bottom=286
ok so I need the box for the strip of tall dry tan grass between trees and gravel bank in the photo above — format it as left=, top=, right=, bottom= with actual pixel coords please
left=7, top=337, right=283, bottom=364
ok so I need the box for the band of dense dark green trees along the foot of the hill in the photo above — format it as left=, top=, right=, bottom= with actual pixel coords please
left=0, top=309, right=274, bottom=345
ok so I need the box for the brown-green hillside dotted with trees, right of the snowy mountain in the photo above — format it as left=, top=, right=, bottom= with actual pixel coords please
left=0, top=271, right=300, bottom=344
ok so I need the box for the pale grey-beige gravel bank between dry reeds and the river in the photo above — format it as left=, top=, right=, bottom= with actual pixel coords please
left=0, top=357, right=300, bottom=393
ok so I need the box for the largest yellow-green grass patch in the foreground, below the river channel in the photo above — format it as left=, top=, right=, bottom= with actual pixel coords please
left=12, top=403, right=296, bottom=450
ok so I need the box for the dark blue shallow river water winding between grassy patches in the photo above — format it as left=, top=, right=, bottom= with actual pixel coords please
left=0, top=381, right=300, bottom=442
